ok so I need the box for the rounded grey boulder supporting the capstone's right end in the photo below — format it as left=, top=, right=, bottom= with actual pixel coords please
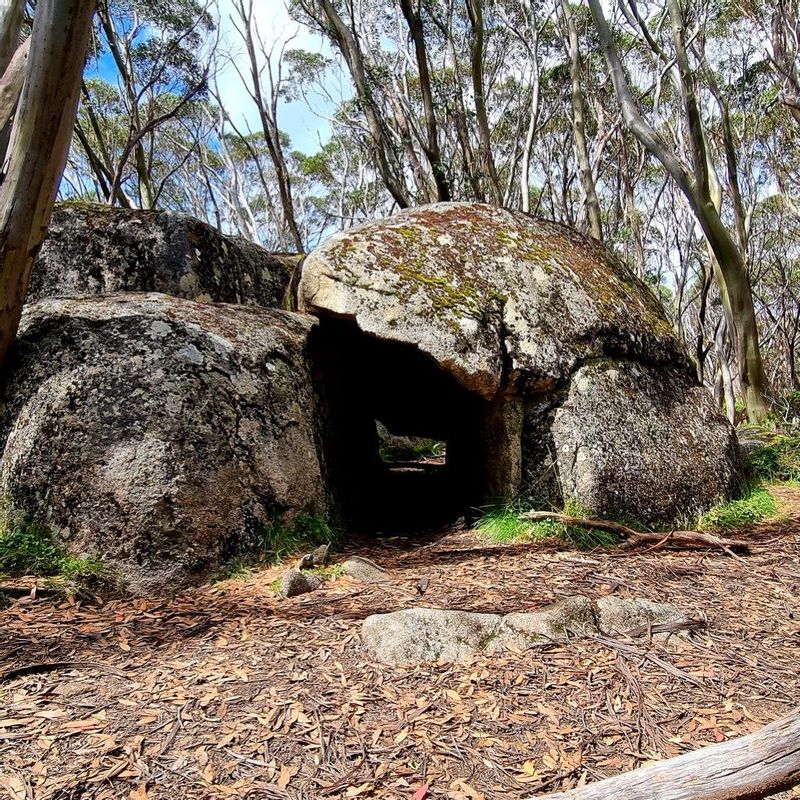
left=548, top=361, right=739, bottom=522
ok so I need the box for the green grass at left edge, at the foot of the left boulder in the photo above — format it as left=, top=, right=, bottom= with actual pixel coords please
left=0, top=511, right=109, bottom=588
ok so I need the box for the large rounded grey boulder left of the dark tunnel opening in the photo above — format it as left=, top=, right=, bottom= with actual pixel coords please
left=0, top=294, right=329, bottom=593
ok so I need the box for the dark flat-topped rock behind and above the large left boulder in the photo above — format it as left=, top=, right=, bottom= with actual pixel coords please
left=28, top=204, right=299, bottom=308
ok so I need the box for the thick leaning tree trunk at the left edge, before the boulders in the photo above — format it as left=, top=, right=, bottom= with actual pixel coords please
left=0, top=0, right=100, bottom=374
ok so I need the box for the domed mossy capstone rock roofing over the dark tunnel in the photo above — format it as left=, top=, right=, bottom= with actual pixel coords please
left=298, top=203, right=686, bottom=398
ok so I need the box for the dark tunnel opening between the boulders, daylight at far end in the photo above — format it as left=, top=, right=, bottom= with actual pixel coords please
left=313, top=317, right=519, bottom=533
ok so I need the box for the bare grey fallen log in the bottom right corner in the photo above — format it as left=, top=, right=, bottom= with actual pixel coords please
left=529, top=709, right=800, bottom=800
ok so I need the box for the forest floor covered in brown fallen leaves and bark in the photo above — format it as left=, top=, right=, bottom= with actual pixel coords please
left=0, top=488, right=800, bottom=800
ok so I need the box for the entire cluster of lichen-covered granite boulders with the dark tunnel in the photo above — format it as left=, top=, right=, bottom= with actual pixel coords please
left=0, top=203, right=738, bottom=592
